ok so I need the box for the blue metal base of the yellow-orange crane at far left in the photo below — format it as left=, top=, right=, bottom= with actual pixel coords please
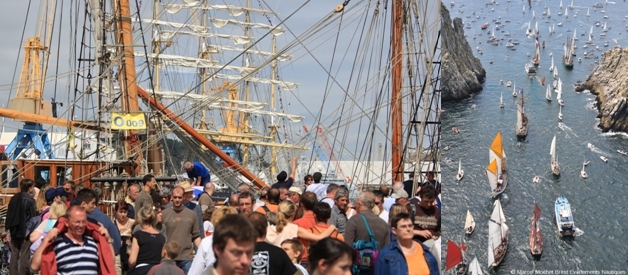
left=5, top=122, right=55, bottom=160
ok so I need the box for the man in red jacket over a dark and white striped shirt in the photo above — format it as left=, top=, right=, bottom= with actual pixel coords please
left=31, top=205, right=115, bottom=275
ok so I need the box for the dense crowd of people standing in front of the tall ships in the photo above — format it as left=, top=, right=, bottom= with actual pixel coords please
left=6, top=165, right=441, bottom=275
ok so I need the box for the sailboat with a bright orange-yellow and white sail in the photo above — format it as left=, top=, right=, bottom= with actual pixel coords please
left=486, top=132, right=508, bottom=197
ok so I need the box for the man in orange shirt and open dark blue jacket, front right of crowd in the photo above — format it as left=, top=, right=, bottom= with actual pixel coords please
left=375, top=213, right=440, bottom=275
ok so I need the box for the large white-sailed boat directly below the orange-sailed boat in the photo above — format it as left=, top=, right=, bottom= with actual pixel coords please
left=488, top=200, right=509, bottom=268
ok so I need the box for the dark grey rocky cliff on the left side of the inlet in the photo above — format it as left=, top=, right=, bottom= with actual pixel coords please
left=441, top=2, right=486, bottom=101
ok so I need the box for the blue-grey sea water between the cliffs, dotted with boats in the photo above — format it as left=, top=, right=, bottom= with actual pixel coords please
left=441, top=0, right=628, bottom=274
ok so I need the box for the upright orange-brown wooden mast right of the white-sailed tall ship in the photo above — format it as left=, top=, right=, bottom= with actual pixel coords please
left=390, top=0, right=403, bottom=183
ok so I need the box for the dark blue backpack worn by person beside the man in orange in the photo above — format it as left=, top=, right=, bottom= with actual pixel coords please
left=351, top=214, right=379, bottom=275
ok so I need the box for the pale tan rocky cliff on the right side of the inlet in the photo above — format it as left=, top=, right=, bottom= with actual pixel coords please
left=576, top=46, right=628, bottom=132
